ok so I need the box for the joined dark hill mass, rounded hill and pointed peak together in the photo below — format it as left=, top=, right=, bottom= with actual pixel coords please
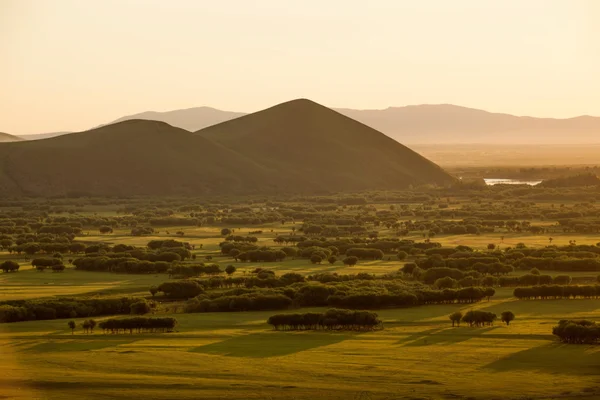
left=0, top=100, right=454, bottom=196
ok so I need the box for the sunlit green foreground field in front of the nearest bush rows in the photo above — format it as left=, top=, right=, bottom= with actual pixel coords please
left=0, top=289, right=600, bottom=399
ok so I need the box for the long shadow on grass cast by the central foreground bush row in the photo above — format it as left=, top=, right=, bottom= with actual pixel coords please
left=190, top=332, right=357, bottom=358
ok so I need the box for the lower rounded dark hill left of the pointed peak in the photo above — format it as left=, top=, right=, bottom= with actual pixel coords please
left=0, top=120, right=276, bottom=196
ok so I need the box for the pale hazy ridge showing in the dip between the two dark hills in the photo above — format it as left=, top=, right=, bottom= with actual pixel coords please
left=104, top=107, right=245, bottom=132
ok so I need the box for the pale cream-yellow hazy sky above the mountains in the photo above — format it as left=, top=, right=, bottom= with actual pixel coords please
left=0, top=0, right=600, bottom=134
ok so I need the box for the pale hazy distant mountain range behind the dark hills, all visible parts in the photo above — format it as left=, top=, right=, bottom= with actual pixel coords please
left=12, top=104, right=600, bottom=145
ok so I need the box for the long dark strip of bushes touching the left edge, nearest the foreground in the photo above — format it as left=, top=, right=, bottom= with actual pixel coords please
left=0, top=297, right=145, bottom=322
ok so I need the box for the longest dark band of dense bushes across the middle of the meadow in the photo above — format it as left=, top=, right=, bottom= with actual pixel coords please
left=179, top=271, right=495, bottom=312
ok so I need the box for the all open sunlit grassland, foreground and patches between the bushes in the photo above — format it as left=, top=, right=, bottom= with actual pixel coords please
left=0, top=191, right=600, bottom=400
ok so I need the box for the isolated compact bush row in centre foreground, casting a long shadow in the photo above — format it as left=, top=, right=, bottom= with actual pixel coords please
left=267, top=308, right=383, bottom=331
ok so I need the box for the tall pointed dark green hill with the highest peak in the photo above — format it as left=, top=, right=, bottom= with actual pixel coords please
left=197, top=99, right=452, bottom=190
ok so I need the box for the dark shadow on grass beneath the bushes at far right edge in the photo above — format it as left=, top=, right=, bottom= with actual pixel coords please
left=482, top=342, right=600, bottom=376
